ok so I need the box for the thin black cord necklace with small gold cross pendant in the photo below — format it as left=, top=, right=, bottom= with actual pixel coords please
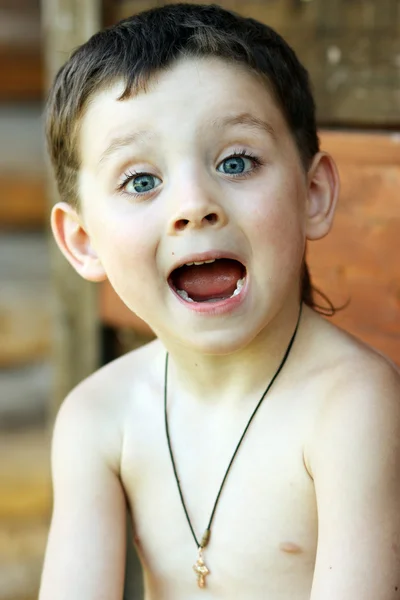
left=164, top=305, right=302, bottom=588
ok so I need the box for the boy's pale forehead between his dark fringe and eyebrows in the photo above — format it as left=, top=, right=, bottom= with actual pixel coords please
left=80, top=58, right=287, bottom=158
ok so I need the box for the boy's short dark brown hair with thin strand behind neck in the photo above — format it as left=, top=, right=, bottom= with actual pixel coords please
left=46, top=4, right=334, bottom=309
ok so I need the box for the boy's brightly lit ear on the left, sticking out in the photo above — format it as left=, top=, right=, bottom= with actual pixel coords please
left=51, top=202, right=107, bottom=281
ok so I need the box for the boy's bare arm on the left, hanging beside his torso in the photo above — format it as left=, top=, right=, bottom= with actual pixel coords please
left=39, top=393, right=126, bottom=600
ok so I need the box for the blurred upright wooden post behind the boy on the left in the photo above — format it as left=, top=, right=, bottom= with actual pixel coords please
left=42, top=0, right=101, bottom=422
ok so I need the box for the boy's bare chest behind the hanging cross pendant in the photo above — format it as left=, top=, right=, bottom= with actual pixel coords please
left=122, top=394, right=317, bottom=600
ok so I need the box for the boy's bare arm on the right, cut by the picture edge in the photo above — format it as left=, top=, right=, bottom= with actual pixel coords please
left=310, top=365, right=400, bottom=600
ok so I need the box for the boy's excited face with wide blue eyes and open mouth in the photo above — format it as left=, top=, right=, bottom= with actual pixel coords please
left=53, top=59, right=332, bottom=353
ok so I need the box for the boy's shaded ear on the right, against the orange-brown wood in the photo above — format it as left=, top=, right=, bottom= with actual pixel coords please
left=306, top=152, right=340, bottom=240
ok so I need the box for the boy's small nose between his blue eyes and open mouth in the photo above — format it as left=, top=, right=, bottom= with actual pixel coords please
left=168, top=171, right=227, bottom=235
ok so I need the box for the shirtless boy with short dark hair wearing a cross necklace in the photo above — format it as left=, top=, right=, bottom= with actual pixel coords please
left=40, top=4, right=400, bottom=600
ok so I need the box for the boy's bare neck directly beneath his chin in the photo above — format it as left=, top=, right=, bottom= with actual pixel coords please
left=159, top=304, right=304, bottom=405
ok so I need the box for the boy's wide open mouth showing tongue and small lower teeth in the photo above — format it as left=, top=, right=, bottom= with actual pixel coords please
left=168, top=258, right=246, bottom=303
